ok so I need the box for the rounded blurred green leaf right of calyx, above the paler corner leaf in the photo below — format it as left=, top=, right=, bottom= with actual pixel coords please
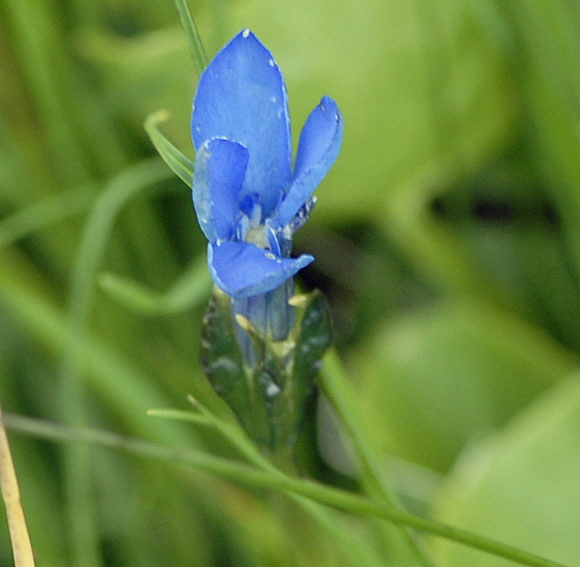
left=355, top=298, right=577, bottom=472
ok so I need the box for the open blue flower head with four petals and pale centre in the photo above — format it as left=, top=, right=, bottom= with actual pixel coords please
left=191, top=29, right=343, bottom=299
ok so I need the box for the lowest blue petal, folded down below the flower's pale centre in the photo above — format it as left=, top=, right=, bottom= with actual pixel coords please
left=208, top=242, right=314, bottom=298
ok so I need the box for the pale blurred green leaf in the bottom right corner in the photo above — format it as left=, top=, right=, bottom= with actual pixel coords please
left=433, top=373, right=580, bottom=567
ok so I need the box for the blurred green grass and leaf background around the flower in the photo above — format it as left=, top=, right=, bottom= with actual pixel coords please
left=0, top=0, right=580, bottom=567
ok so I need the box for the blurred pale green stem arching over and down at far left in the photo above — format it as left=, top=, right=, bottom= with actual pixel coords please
left=59, top=159, right=177, bottom=567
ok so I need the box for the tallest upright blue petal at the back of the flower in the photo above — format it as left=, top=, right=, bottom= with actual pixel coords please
left=191, top=30, right=291, bottom=217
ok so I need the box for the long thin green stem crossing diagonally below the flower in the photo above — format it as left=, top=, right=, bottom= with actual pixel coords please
left=4, top=415, right=566, bottom=567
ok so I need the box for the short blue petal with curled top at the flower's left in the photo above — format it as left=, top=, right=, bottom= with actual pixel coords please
left=192, top=138, right=248, bottom=242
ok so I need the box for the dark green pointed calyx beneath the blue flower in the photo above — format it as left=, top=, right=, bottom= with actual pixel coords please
left=202, top=288, right=330, bottom=454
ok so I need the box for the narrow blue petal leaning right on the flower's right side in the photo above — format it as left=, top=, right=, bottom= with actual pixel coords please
left=279, top=96, right=343, bottom=226
